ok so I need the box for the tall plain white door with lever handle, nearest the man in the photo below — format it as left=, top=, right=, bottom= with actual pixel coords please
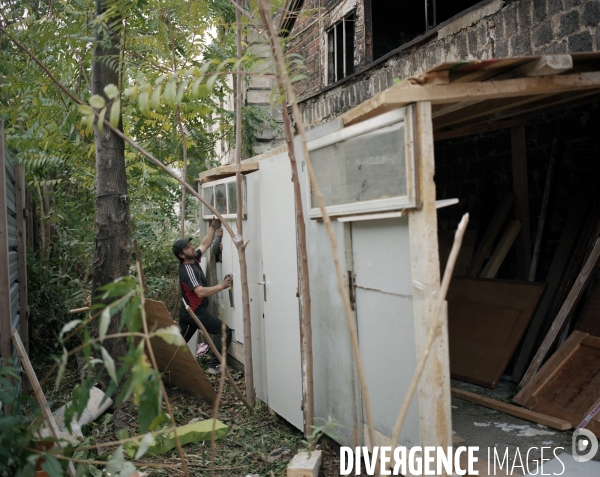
left=259, top=155, right=304, bottom=429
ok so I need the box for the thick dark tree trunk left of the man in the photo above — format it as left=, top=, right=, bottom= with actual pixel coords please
left=92, top=0, right=131, bottom=392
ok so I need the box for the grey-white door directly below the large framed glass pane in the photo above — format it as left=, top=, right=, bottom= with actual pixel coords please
left=352, top=217, right=420, bottom=447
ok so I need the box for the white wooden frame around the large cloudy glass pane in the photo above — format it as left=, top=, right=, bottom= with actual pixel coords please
left=305, top=106, right=419, bottom=219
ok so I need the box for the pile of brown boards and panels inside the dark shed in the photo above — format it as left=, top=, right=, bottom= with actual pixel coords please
left=440, top=141, right=600, bottom=437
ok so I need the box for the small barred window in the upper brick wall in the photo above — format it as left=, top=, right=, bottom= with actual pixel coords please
left=327, top=13, right=355, bottom=84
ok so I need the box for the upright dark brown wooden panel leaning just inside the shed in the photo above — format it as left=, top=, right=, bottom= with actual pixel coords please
left=448, top=278, right=545, bottom=389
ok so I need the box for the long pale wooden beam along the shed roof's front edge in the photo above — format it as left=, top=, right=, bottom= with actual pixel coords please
left=342, top=71, right=600, bottom=126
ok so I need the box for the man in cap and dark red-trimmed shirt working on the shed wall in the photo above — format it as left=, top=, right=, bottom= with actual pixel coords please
left=173, top=219, right=233, bottom=374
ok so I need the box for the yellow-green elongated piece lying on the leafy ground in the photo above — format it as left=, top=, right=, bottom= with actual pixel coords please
left=124, top=419, right=227, bottom=457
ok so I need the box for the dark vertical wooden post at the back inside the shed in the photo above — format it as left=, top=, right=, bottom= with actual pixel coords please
left=510, top=126, right=531, bottom=280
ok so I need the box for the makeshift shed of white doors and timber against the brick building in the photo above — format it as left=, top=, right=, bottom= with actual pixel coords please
left=200, top=54, right=600, bottom=447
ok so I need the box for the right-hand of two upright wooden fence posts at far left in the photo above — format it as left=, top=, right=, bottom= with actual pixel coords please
left=15, top=164, right=29, bottom=354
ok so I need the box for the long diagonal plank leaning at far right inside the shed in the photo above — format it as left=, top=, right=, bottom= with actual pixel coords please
left=512, top=184, right=595, bottom=382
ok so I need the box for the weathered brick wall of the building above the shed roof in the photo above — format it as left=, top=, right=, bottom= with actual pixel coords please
left=290, top=0, right=600, bottom=128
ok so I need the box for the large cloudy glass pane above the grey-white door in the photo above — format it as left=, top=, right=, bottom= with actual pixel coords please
left=310, top=122, right=407, bottom=207
